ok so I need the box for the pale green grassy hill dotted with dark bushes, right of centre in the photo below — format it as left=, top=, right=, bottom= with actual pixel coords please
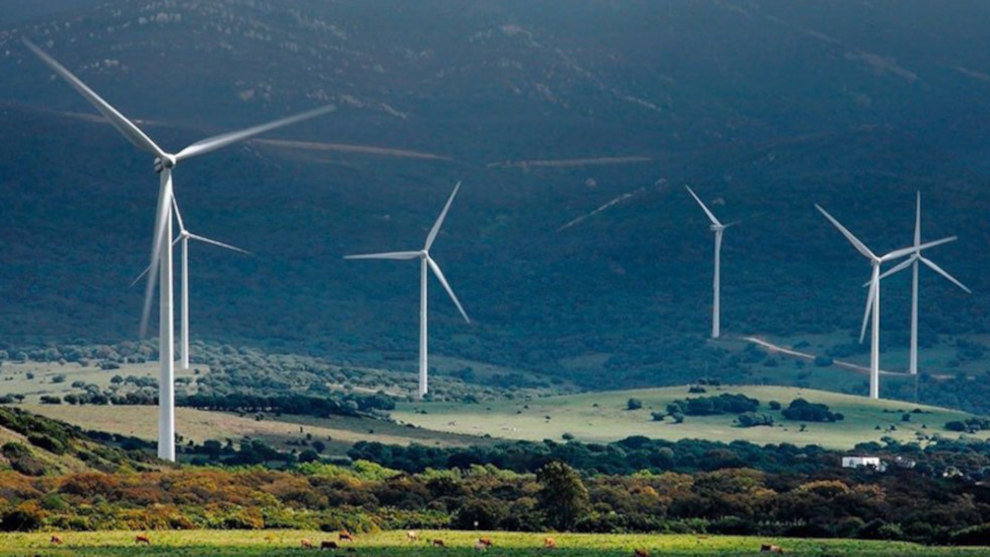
left=392, top=386, right=988, bottom=449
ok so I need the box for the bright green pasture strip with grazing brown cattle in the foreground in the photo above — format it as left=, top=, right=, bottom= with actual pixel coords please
left=0, top=530, right=986, bottom=557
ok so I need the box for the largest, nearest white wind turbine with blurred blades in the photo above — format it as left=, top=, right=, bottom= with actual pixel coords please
left=23, top=38, right=334, bottom=462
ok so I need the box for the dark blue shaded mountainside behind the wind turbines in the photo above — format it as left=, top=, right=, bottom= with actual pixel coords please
left=0, top=0, right=990, bottom=411
